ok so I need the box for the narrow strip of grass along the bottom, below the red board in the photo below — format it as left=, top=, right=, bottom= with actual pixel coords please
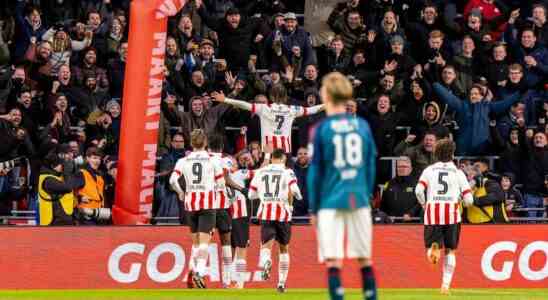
left=0, top=289, right=548, bottom=300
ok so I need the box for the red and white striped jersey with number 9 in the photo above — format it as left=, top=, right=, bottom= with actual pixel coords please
left=173, top=151, right=225, bottom=211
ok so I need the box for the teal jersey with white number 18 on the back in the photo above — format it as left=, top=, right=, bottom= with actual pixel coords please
left=307, top=114, right=377, bottom=214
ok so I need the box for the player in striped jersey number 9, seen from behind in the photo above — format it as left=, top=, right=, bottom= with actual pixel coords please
left=169, top=129, right=224, bottom=288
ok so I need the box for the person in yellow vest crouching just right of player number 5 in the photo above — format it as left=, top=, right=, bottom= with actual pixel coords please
left=466, top=176, right=508, bottom=224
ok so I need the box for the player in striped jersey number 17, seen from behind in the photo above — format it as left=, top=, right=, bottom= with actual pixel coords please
left=249, top=149, right=302, bottom=293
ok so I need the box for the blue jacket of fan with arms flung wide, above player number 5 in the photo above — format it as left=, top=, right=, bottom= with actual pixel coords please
left=433, top=82, right=520, bottom=155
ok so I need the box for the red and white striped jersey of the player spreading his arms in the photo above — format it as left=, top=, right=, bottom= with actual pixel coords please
left=251, top=103, right=323, bottom=153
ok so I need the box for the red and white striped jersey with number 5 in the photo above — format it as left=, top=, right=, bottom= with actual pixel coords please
left=416, top=162, right=470, bottom=225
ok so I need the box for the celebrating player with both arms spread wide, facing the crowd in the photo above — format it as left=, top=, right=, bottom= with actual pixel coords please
left=211, top=86, right=323, bottom=153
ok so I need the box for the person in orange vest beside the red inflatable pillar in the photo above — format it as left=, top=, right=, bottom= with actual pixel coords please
left=74, top=147, right=110, bottom=225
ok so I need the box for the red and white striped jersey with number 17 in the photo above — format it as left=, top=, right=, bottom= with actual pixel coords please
left=249, top=164, right=301, bottom=222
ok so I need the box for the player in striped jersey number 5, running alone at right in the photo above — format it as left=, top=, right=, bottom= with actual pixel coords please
left=415, top=139, right=474, bottom=294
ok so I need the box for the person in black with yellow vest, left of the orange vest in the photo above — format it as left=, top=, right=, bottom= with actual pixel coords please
left=38, top=152, right=75, bottom=226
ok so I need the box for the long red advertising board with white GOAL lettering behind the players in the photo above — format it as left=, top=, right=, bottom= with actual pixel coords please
left=0, top=225, right=548, bottom=289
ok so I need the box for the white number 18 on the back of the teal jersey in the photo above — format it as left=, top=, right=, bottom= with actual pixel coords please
left=333, top=132, right=362, bottom=168
